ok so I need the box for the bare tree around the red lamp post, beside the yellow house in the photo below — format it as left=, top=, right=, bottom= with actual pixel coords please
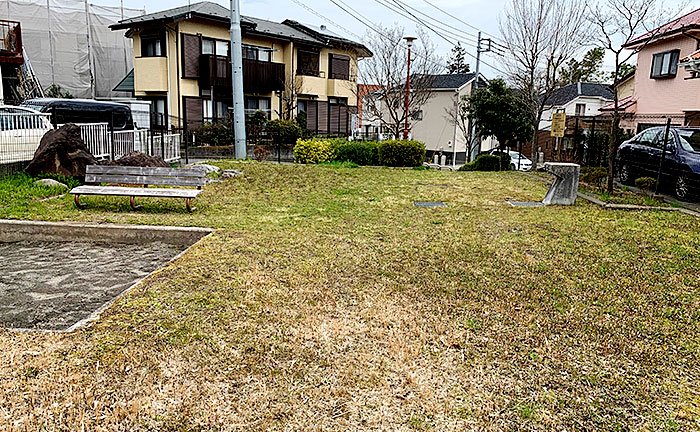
left=353, top=25, right=443, bottom=138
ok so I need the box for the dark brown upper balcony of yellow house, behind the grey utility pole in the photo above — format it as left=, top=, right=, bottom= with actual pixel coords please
left=199, top=54, right=285, bottom=94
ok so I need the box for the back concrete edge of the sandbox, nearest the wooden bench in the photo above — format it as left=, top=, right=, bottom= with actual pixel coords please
left=0, top=219, right=214, bottom=246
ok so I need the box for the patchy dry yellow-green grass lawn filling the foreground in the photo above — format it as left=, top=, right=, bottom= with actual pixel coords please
left=0, top=163, right=700, bottom=431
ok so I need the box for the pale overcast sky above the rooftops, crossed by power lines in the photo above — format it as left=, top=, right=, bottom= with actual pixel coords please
left=116, top=0, right=700, bottom=78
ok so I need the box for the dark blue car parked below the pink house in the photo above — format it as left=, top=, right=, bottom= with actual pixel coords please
left=616, top=127, right=700, bottom=199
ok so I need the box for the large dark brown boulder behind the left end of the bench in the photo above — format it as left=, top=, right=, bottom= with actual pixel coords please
left=25, top=123, right=97, bottom=177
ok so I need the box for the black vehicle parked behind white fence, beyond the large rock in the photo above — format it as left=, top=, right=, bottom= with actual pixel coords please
left=20, top=98, right=134, bottom=130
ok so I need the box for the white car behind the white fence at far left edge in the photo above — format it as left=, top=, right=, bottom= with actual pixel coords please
left=0, top=105, right=52, bottom=163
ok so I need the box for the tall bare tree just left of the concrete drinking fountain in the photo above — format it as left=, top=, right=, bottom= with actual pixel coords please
left=500, top=0, right=590, bottom=169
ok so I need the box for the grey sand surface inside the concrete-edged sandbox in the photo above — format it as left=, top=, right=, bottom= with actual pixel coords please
left=0, top=242, right=182, bottom=330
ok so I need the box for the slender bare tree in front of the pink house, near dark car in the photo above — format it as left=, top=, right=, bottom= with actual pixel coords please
left=589, top=0, right=684, bottom=193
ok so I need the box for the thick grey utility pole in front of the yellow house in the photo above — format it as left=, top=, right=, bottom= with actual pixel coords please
left=230, top=0, right=247, bottom=159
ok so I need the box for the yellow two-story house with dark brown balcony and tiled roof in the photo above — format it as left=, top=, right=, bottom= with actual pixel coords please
left=110, top=2, right=372, bottom=135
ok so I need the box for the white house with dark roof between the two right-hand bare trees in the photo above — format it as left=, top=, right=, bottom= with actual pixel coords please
left=539, top=82, right=613, bottom=130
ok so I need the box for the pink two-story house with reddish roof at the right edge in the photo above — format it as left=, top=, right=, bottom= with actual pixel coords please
left=621, top=9, right=700, bottom=131
